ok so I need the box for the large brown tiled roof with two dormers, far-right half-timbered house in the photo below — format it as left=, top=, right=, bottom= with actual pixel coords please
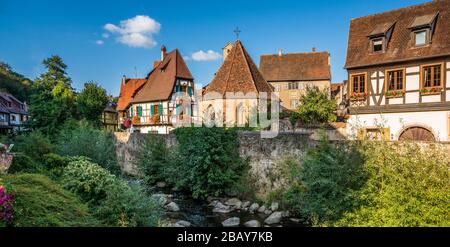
left=345, top=0, right=450, bottom=69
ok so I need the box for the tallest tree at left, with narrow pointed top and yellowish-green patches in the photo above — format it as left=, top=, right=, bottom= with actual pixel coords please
left=29, top=56, right=75, bottom=134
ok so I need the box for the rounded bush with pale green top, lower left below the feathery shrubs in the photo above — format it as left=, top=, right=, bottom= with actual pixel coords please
left=62, top=157, right=117, bottom=205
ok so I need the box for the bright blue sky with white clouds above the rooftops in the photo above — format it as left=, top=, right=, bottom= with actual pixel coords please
left=0, top=0, right=426, bottom=95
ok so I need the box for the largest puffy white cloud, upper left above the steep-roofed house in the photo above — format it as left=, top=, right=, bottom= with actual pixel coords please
left=103, top=15, right=161, bottom=48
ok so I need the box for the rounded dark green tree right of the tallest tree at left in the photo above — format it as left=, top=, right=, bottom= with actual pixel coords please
left=77, top=82, right=109, bottom=126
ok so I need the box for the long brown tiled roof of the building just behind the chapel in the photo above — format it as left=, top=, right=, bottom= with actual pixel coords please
left=259, top=52, right=331, bottom=81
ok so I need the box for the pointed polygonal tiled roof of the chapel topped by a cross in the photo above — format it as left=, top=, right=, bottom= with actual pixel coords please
left=204, top=40, right=273, bottom=95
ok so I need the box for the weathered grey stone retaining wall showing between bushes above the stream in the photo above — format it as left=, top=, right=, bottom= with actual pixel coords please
left=115, top=132, right=316, bottom=195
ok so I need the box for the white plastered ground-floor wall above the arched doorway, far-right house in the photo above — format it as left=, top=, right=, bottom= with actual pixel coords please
left=347, top=109, right=450, bottom=141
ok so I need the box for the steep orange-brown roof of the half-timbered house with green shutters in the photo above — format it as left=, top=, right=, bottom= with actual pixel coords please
left=131, top=49, right=194, bottom=103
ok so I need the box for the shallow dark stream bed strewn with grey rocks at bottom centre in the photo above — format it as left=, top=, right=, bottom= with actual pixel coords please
left=152, top=184, right=305, bottom=227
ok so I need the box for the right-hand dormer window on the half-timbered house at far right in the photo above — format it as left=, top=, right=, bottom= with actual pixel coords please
left=409, top=13, right=439, bottom=47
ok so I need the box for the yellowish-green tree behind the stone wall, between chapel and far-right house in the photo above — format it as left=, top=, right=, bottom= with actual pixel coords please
left=291, top=86, right=337, bottom=124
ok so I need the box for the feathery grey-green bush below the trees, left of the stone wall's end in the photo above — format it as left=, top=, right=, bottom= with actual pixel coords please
left=56, top=121, right=120, bottom=174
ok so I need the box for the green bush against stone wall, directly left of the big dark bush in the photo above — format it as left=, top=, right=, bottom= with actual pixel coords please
left=136, top=135, right=172, bottom=184
